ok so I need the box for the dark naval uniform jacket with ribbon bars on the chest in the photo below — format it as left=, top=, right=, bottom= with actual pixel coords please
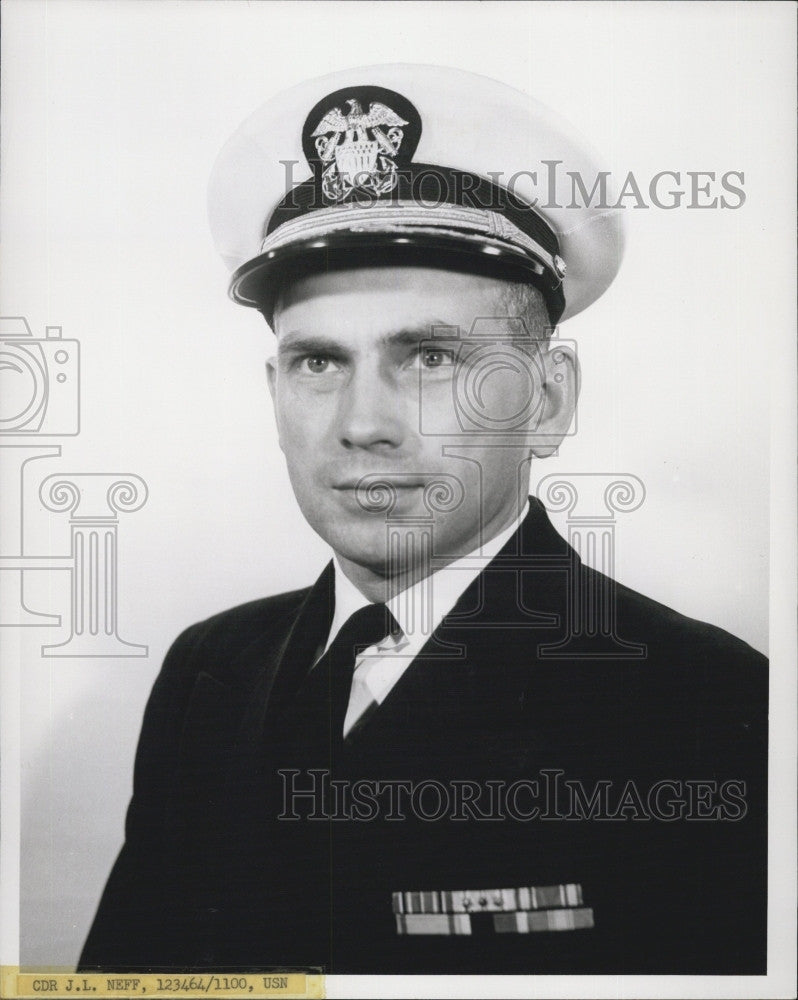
left=80, top=499, right=767, bottom=974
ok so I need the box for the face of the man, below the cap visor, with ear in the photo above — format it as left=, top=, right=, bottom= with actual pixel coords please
left=268, top=266, right=576, bottom=577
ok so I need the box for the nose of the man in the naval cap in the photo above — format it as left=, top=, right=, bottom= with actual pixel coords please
left=338, top=365, right=404, bottom=450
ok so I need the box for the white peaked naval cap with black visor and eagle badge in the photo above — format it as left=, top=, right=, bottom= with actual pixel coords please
left=208, top=64, right=624, bottom=321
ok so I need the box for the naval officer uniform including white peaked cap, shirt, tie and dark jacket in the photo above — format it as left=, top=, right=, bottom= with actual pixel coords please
left=80, top=66, right=767, bottom=974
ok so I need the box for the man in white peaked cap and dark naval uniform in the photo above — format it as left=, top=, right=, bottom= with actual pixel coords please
left=80, top=66, right=767, bottom=973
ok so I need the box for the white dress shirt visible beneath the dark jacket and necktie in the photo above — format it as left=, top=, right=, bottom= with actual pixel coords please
left=322, top=500, right=529, bottom=737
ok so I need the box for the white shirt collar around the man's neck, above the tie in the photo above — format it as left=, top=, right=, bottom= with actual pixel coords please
left=324, top=500, right=529, bottom=652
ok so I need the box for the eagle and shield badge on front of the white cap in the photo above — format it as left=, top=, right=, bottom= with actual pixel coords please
left=302, top=87, right=421, bottom=203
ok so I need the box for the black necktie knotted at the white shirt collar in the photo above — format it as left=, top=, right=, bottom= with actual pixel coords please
left=294, top=604, right=399, bottom=739
